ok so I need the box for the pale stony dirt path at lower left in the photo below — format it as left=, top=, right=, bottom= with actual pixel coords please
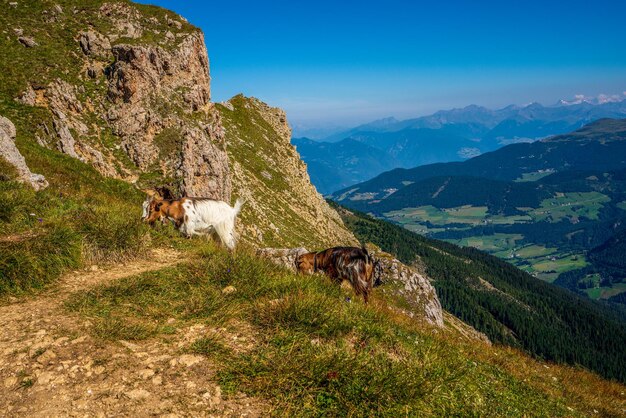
left=0, top=250, right=264, bottom=417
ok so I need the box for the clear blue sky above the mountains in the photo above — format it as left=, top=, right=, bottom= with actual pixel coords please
left=134, top=0, right=626, bottom=126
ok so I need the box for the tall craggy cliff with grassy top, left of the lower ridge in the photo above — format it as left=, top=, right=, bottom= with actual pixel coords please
left=0, top=1, right=231, bottom=200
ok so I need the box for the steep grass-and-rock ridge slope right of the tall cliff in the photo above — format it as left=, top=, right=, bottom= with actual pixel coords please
left=217, top=95, right=356, bottom=248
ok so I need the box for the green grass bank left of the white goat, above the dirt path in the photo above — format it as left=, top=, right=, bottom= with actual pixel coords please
left=0, top=147, right=152, bottom=296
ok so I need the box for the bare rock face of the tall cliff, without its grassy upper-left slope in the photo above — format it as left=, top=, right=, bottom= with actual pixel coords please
left=16, top=2, right=232, bottom=203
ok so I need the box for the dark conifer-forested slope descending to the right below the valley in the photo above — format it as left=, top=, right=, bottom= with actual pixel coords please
left=340, top=204, right=626, bottom=381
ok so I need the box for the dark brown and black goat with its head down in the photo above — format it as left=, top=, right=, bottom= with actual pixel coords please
left=296, top=247, right=377, bottom=303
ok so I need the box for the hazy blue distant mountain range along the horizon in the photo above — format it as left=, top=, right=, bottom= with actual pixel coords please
left=292, top=98, right=626, bottom=194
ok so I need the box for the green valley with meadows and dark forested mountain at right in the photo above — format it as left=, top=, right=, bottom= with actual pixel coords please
left=332, top=119, right=626, bottom=303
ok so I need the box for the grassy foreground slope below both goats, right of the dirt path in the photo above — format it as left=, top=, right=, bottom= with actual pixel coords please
left=67, top=244, right=596, bottom=416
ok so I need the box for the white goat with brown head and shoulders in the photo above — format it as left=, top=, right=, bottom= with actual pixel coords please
left=142, top=195, right=244, bottom=250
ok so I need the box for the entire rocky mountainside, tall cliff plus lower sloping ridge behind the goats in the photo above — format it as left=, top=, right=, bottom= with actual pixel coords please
left=0, top=1, right=356, bottom=247
